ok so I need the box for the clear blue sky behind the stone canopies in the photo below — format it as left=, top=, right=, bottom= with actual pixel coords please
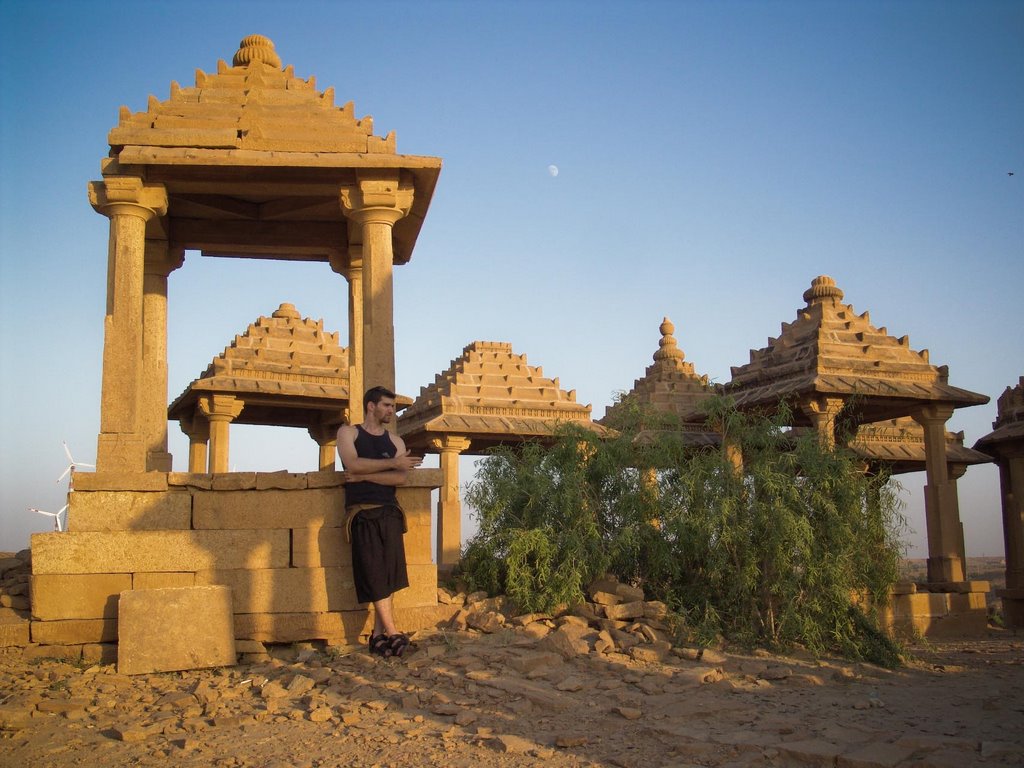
left=0, top=0, right=1024, bottom=556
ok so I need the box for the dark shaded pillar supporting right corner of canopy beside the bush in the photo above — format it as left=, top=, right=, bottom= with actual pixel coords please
left=911, top=402, right=964, bottom=584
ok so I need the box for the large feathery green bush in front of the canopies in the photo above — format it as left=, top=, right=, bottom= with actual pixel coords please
left=461, top=398, right=903, bottom=665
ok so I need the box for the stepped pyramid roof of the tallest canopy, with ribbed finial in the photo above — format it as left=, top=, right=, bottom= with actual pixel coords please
left=103, top=35, right=441, bottom=263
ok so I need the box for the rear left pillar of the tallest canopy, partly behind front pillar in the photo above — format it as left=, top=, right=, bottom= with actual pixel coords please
left=141, top=240, right=185, bottom=472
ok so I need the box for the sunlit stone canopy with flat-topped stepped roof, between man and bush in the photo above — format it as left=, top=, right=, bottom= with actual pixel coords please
left=398, top=341, right=608, bottom=572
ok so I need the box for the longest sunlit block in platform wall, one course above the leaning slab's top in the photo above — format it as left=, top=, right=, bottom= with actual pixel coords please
left=32, top=529, right=290, bottom=573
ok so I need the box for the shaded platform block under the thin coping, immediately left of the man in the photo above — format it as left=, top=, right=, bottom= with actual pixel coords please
left=193, top=488, right=344, bottom=530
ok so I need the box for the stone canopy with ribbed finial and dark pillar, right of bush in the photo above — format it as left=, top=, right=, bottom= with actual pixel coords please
left=723, top=274, right=988, bottom=590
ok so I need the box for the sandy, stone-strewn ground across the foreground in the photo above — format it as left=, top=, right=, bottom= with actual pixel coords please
left=0, top=630, right=1024, bottom=768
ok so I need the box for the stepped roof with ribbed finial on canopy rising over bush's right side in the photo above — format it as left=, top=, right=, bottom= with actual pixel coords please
left=725, top=275, right=988, bottom=424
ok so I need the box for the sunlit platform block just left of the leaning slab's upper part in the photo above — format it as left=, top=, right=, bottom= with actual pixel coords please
left=32, top=573, right=132, bottom=621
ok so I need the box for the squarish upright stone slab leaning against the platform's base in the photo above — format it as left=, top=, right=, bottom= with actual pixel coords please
left=118, top=586, right=236, bottom=675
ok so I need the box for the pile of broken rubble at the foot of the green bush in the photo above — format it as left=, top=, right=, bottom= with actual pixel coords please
left=437, top=575, right=720, bottom=662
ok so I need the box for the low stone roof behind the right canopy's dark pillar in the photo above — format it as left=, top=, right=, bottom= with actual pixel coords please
left=850, top=416, right=991, bottom=474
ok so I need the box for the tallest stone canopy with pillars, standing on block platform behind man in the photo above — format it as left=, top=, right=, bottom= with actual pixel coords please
left=88, top=35, right=441, bottom=473
